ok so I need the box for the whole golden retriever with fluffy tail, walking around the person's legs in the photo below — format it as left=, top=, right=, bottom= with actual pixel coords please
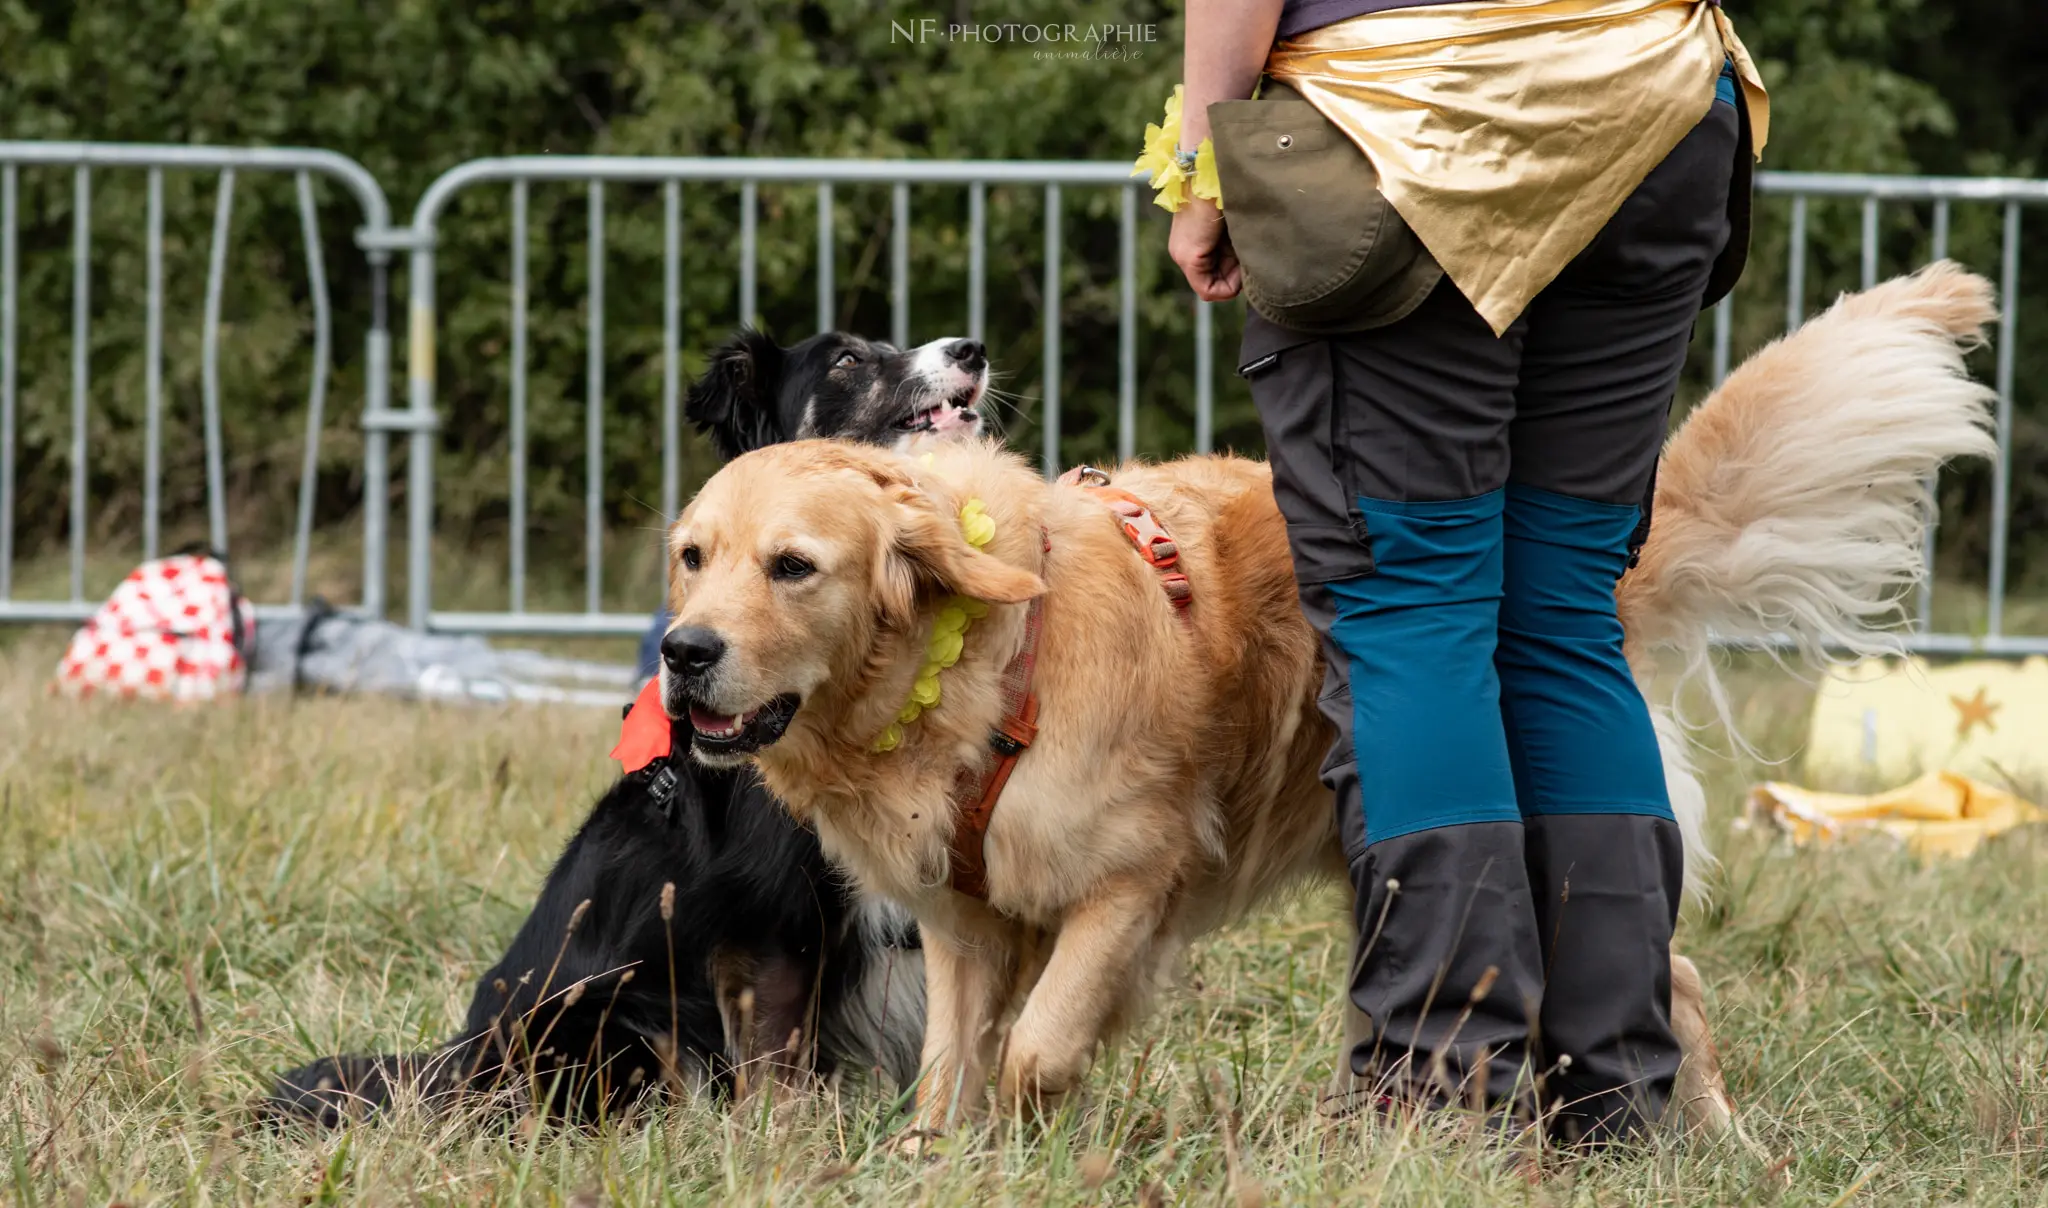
left=664, top=264, right=1993, bottom=1128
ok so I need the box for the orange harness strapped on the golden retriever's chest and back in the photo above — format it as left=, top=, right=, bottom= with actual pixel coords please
left=950, top=465, right=1194, bottom=901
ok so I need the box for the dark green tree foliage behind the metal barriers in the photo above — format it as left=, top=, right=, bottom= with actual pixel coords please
left=0, top=0, right=2048, bottom=606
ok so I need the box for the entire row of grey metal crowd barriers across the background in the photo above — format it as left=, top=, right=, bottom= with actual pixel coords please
left=0, top=143, right=2048, bottom=653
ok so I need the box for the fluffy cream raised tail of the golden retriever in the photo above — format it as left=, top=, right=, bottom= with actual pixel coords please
left=1618, top=260, right=1997, bottom=888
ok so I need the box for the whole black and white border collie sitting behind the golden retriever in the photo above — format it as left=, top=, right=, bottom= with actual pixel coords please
left=258, top=330, right=989, bottom=1126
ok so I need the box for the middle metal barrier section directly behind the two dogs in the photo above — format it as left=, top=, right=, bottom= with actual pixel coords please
left=406, top=156, right=1179, bottom=635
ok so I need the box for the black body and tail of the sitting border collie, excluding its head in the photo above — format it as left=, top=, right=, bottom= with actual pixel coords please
left=268, top=725, right=924, bottom=1124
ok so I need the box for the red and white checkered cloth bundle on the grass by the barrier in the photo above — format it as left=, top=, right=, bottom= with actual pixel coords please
left=57, top=555, right=256, bottom=700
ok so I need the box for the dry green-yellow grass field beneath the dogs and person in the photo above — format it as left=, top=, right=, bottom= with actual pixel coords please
left=0, top=631, right=2048, bottom=1206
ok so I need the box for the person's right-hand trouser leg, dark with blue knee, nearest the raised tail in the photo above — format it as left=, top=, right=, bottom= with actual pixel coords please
left=1495, top=87, right=1737, bottom=1138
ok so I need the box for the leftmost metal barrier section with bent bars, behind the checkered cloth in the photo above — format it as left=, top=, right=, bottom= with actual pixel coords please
left=0, top=141, right=391, bottom=622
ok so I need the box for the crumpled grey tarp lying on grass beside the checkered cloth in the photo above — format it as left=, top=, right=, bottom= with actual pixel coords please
left=248, top=610, right=639, bottom=708
